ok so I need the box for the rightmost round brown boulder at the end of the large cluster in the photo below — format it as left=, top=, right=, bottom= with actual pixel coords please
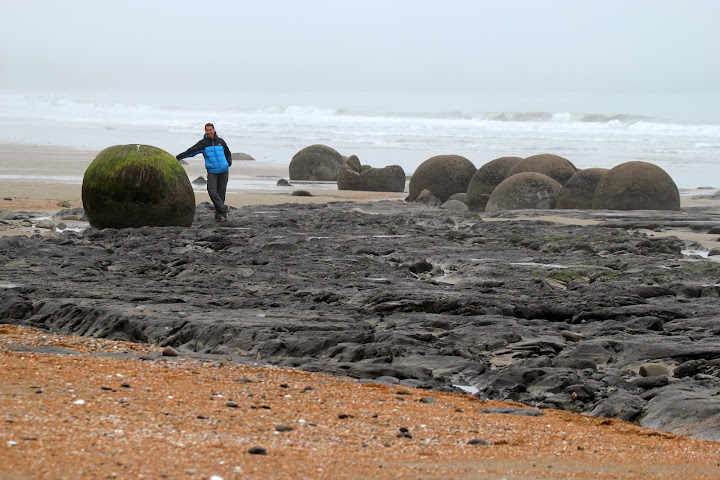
left=593, top=162, right=680, bottom=210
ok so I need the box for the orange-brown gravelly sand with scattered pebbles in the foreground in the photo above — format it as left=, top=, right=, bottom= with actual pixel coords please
left=0, top=325, right=720, bottom=480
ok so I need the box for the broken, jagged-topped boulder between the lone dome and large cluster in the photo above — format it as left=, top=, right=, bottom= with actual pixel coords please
left=338, top=155, right=405, bottom=192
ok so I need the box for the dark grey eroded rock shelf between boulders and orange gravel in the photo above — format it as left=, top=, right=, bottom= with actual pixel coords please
left=0, top=201, right=720, bottom=440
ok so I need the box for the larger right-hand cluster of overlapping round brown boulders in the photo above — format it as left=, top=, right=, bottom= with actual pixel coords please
left=406, top=153, right=680, bottom=213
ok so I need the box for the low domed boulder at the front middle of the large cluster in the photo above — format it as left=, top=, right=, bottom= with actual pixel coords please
left=485, top=172, right=562, bottom=213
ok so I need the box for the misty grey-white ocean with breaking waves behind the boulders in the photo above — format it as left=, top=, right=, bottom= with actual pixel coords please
left=0, top=89, right=720, bottom=189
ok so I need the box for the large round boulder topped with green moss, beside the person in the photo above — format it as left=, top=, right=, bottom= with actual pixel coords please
left=82, top=144, right=195, bottom=228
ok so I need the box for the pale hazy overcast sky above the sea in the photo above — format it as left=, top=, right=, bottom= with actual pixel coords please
left=0, top=0, right=720, bottom=93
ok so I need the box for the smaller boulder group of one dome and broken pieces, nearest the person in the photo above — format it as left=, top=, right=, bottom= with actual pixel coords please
left=289, top=145, right=405, bottom=192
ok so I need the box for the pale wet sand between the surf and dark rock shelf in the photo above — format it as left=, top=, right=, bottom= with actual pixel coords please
left=0, top=143, right=720, bottom=261
